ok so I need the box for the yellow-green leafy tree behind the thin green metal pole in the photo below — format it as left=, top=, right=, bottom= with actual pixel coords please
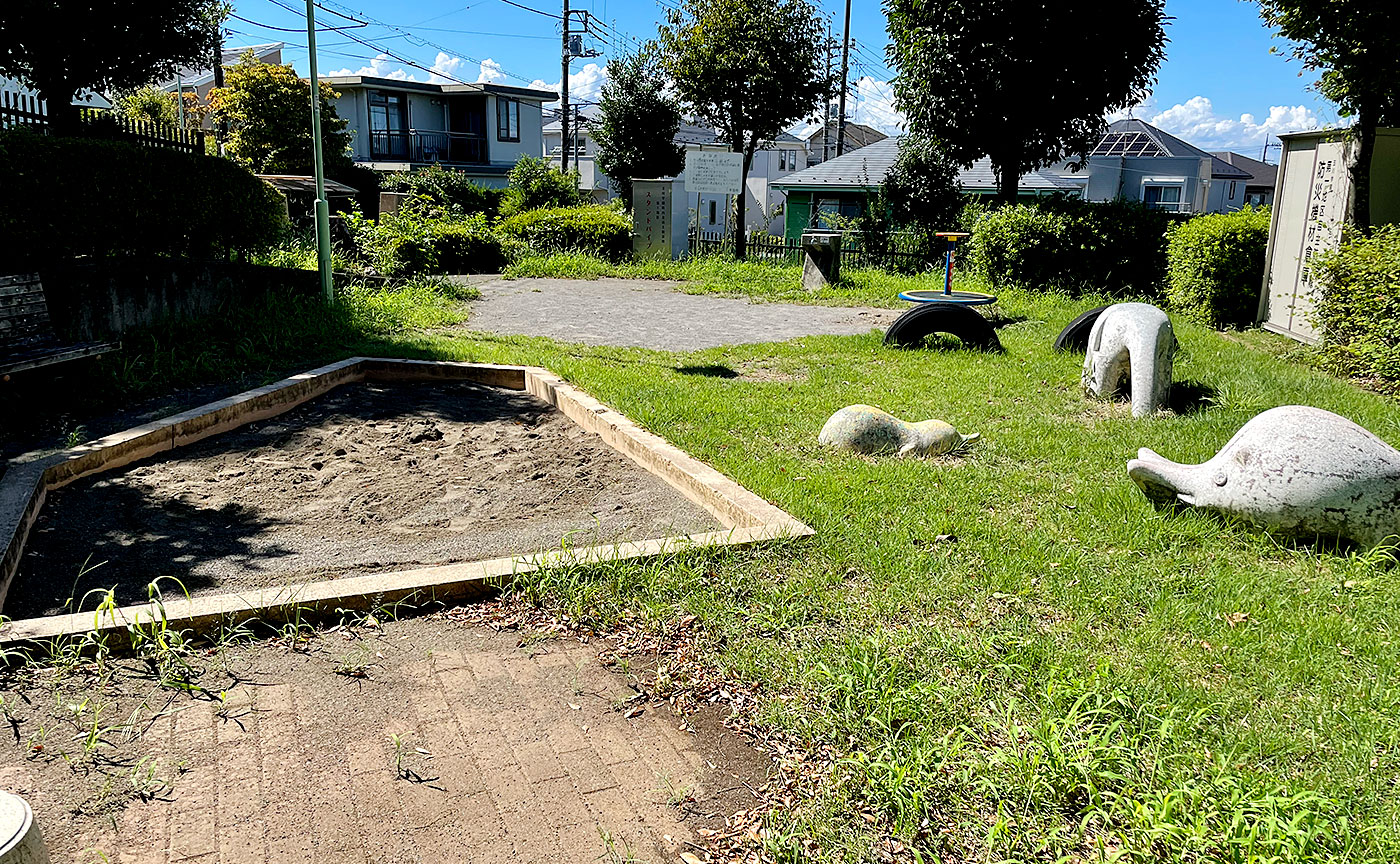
left=209, top=52, right=350, bottom=174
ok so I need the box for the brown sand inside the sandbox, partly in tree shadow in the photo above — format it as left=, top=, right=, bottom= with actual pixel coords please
left=16, top=384, right=721, bottom=618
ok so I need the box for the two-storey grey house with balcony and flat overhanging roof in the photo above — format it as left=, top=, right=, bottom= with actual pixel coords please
left=323, top=76, right=557, bottom=188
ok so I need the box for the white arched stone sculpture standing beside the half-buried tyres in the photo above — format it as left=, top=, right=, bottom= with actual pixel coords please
left=1084, top=302, right=1176, bottom=417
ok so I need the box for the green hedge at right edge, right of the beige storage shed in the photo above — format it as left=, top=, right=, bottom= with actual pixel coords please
left=1313, top=225, right=1400, bottom=385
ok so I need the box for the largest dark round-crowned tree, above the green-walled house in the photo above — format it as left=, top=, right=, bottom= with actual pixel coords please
left=885, top=0, right=1166, bottom=202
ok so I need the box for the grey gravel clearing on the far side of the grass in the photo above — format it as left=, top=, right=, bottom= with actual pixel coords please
left=466, top=279, right=900, bottom=351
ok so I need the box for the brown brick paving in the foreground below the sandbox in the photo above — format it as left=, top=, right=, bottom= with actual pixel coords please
left=8, top=622, right=704, bottom=864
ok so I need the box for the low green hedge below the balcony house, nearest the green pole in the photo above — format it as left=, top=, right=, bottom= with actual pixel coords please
left=351, top=213, right=505, bottom=276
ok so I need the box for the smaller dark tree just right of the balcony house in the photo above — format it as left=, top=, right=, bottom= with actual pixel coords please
left=594, top=42, right=685, bottom=210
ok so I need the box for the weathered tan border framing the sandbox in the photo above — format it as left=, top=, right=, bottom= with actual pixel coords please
left=0, top=357, right=813, bottom=643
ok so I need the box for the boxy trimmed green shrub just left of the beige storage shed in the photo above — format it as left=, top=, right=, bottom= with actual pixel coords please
left=1166, top=207, right=1268, bottom=328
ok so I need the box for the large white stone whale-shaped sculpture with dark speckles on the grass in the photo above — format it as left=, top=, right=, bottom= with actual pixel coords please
left=1128, top=405, right=1400, bottom=548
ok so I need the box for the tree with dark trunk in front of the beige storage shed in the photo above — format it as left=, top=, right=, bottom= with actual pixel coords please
left=1259, top=0, right=1400, bottom=230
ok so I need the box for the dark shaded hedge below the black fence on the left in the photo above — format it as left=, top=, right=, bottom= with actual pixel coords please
left=0, top=130, right=288, bottom=270
